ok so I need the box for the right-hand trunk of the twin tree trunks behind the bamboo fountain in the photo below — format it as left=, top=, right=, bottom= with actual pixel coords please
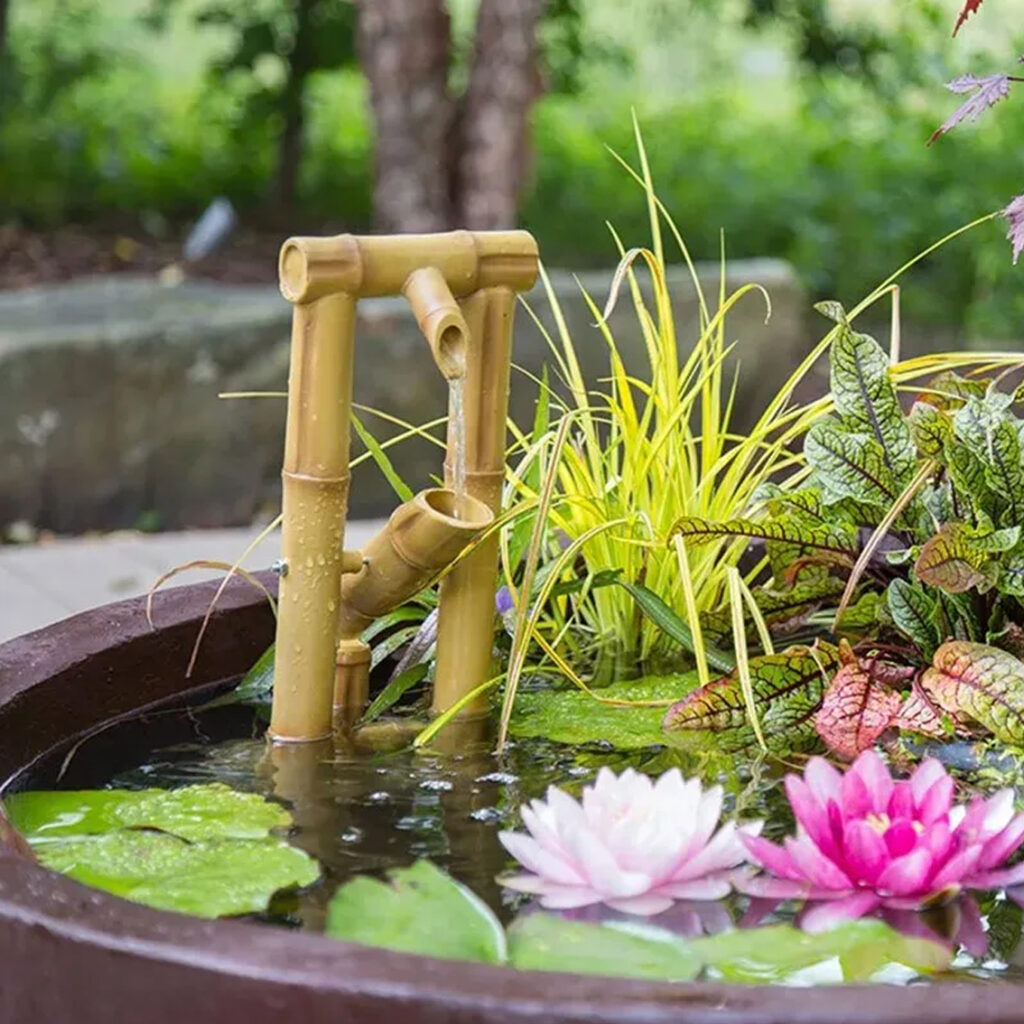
left=456, top=0, right=544, bottom=230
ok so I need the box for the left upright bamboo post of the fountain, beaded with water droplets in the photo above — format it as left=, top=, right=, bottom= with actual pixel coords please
left=270, top=292, right=355, bottom=742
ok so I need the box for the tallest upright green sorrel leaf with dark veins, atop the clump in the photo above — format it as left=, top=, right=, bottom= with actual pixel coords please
left=829, top=326, right=916, bottom=487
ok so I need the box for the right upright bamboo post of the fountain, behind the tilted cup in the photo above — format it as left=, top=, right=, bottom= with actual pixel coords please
left=431, top=287, right=515, bottom=715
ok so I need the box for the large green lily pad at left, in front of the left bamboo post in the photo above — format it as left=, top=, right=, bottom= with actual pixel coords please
left=8, top=783, right=319, bottom=918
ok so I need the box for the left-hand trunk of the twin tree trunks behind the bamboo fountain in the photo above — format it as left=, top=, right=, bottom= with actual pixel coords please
left=358, top=0, right=454, bottom=231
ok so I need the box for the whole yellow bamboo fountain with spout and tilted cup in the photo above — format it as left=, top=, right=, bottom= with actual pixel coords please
left=269, top=231, right=538, bottom=744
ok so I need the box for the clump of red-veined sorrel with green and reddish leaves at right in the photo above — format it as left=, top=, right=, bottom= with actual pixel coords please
left=666, top=303, right=1024, bottom=758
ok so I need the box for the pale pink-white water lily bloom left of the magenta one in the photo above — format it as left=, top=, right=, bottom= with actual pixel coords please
left=500, top=768, right=761, bottom=914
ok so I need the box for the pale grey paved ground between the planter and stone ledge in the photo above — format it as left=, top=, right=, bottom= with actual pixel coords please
left=0, top=521, right=380, bottom=643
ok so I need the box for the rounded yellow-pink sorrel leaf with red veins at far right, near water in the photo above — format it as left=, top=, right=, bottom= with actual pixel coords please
left=921, top=640, right=1024, bottom=743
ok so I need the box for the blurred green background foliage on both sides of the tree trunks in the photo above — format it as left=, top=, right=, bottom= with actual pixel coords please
left=6, top=0, right=1024, bottom=337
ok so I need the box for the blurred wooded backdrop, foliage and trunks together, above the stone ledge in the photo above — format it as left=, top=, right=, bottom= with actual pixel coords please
left=0, top=0, right=1024, bottom=341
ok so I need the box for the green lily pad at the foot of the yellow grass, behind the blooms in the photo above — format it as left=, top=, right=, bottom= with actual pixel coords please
left=510, top=672, right=697, bottom=751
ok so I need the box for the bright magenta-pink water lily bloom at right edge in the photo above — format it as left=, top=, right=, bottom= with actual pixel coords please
left=737, top=751, right=1024, bottom=931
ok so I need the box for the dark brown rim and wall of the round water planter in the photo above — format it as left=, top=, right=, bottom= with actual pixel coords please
left=0, top=574, right=1022, bottom=1024
